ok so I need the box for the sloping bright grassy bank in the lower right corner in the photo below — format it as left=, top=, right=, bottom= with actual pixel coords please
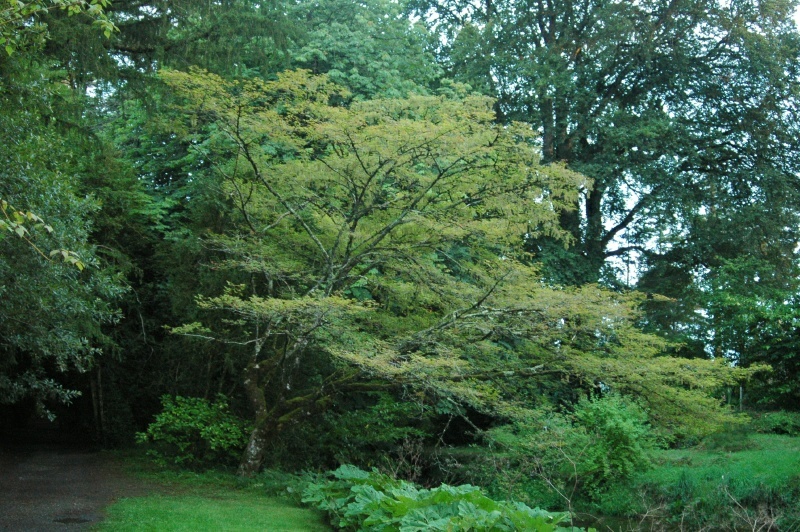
left=597, top=432, right=800, bottom=530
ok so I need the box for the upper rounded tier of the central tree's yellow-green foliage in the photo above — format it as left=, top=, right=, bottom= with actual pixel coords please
left=163, top=66, right=587, bottom=298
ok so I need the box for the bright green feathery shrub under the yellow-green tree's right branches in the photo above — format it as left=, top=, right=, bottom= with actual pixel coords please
left=454, top=394, right=659, bottom=508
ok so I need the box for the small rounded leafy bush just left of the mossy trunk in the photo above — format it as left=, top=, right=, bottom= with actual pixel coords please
left=136, top=395, right=249, bottom=468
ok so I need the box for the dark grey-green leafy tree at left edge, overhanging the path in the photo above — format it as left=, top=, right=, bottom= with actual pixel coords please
left=0, top=56, right=124, bottom=415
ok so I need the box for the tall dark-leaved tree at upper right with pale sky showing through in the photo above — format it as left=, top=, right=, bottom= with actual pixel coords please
left=415, top=0, right=800, bottom=282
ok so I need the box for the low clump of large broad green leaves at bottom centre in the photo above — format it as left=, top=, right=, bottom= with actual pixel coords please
left=303, top=466, right=569, bottom=532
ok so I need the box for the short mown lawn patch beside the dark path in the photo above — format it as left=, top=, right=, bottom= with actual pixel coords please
left=98, top=491, right=330, bottom=531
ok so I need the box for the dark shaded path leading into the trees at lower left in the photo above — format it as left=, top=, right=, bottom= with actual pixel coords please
left=0, top=444, right=151, bottom=532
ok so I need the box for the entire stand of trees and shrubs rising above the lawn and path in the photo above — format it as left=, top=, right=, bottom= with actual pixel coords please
left=0, top=0, right=800, bottom=528
